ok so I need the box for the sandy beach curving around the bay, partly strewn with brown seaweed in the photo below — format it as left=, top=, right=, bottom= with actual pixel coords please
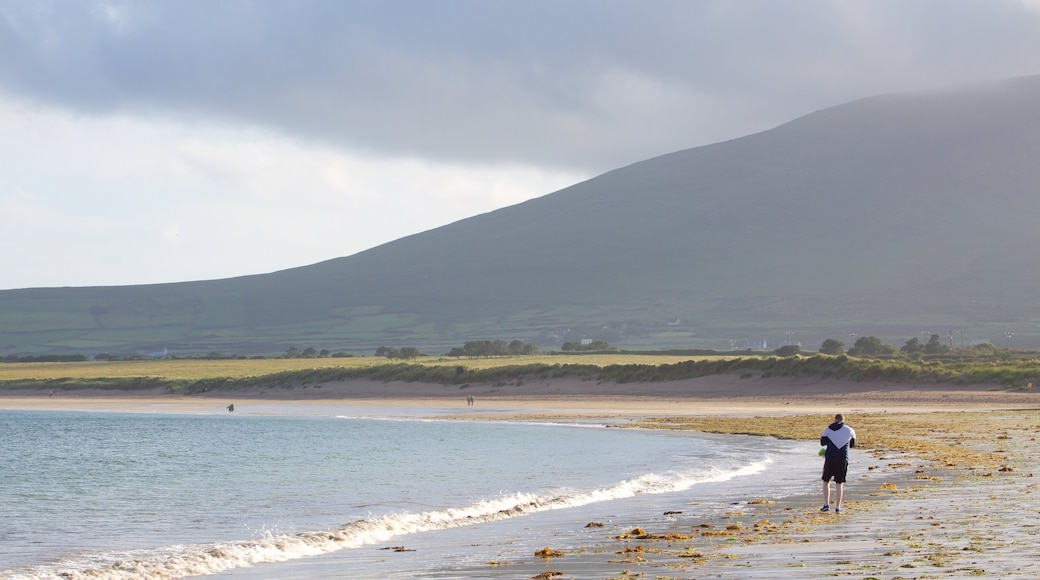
left=0, top=376, right=1040, bottom=578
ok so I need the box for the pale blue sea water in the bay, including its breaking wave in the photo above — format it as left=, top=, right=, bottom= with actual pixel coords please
left=0, top=410, right=820, bottom=580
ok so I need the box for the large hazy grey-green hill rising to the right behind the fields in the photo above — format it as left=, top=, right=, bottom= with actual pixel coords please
left=0, top=77, right=1040, bottom=354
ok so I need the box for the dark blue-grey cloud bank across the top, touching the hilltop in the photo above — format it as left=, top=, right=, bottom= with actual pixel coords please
left=0, top=0, right=1040, bottom=172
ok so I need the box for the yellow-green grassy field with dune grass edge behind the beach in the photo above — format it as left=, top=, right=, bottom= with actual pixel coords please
left=6, top=353, right=1040, bottom=392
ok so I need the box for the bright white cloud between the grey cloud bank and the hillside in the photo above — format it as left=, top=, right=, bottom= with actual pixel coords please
left=0, top=96, right=590, bottom=287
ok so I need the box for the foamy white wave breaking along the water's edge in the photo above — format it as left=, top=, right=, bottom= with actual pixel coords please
left=0, top=458, right=772, bottom=580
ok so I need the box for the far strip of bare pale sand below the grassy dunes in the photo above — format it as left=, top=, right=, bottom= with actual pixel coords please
left=0, top=375, right=1040, bottom=417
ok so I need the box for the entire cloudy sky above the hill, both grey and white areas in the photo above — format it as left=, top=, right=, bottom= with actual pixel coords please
left=0, top=0, right=1040, bottom=289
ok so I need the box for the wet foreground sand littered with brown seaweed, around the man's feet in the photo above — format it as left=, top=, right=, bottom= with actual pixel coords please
left=443, top=411, right=1040, bottom=579
